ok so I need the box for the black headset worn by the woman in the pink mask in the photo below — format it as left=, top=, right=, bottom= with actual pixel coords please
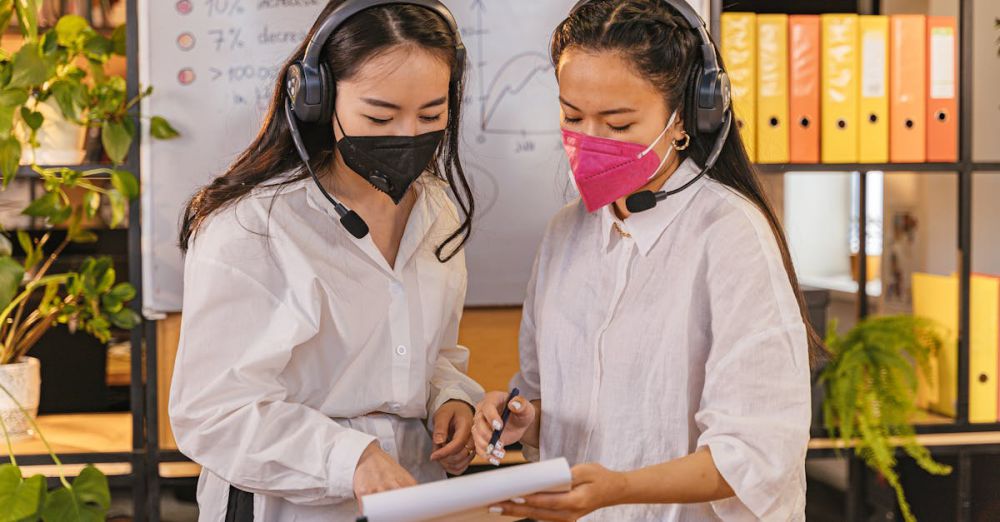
left=570, top=0, right=733, bottom=212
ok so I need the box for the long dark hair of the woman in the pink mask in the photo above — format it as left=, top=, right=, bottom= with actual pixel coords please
left=551, top=0, right=827, bottom=365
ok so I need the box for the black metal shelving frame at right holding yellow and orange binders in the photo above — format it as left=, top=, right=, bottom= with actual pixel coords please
left=709, top=0, right=1000, bottom=522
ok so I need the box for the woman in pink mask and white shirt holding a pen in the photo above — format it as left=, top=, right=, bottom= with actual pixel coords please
left=473, top=0, right=823, bottom=521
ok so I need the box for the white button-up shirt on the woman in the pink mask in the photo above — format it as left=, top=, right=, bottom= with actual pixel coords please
left=512, top=160, right=810, bottom=522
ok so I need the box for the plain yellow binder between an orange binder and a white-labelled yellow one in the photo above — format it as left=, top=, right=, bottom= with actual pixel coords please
left=820, top=14, right=858, bottom=163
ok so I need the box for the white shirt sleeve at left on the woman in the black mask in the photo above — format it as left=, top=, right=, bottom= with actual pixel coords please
left=169, top=254, right=376, bottom=505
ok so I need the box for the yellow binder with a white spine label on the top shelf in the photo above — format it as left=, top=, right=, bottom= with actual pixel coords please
left=858, top=15, right=889, bottom=163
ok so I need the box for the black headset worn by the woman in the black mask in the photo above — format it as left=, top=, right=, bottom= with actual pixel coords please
left=285, top=0, right=465, bottom=239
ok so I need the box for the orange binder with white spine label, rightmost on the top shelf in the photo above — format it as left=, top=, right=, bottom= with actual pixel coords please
left=927, top=16, right=958, bottom=163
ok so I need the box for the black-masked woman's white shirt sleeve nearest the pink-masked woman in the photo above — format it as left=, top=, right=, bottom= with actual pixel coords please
left=427, top=268, right=483, bottom=422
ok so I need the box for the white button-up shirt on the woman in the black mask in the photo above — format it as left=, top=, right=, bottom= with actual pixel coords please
left=170, top=176, right=482, bottom=522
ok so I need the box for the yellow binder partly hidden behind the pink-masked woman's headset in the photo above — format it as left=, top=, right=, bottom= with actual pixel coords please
left=722, top=12, right=757, bottom=161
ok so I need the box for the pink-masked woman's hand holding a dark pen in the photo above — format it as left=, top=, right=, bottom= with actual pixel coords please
left=472, top=391, right=535, bottom=466
